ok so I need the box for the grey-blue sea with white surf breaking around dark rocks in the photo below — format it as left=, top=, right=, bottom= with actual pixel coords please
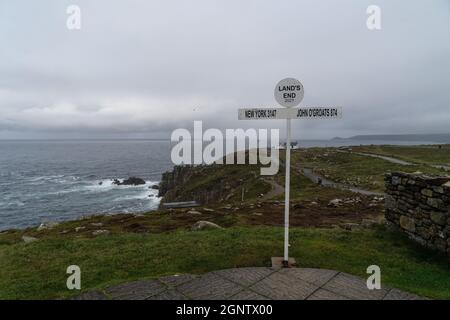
left=0, top=140, right=442, bottom=231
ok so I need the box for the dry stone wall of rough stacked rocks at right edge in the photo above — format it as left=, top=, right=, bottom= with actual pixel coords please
left=385, top=172, right=450, bottom=256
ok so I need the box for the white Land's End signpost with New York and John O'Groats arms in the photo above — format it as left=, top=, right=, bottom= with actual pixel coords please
left=238, top=78, right=342, bottom=267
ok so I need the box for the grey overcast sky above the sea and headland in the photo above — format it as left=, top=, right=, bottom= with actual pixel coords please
left=0, top=0, right=450, bottom=139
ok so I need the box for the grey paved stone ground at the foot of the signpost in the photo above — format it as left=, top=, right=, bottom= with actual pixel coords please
left=75, top=268, right=428, bottom=300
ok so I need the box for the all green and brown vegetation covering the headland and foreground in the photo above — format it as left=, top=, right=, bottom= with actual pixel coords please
left=0, top=146, right=450, bottom=299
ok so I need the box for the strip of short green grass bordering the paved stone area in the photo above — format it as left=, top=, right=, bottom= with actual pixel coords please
left=0, top=227, right=450, bottom=299
